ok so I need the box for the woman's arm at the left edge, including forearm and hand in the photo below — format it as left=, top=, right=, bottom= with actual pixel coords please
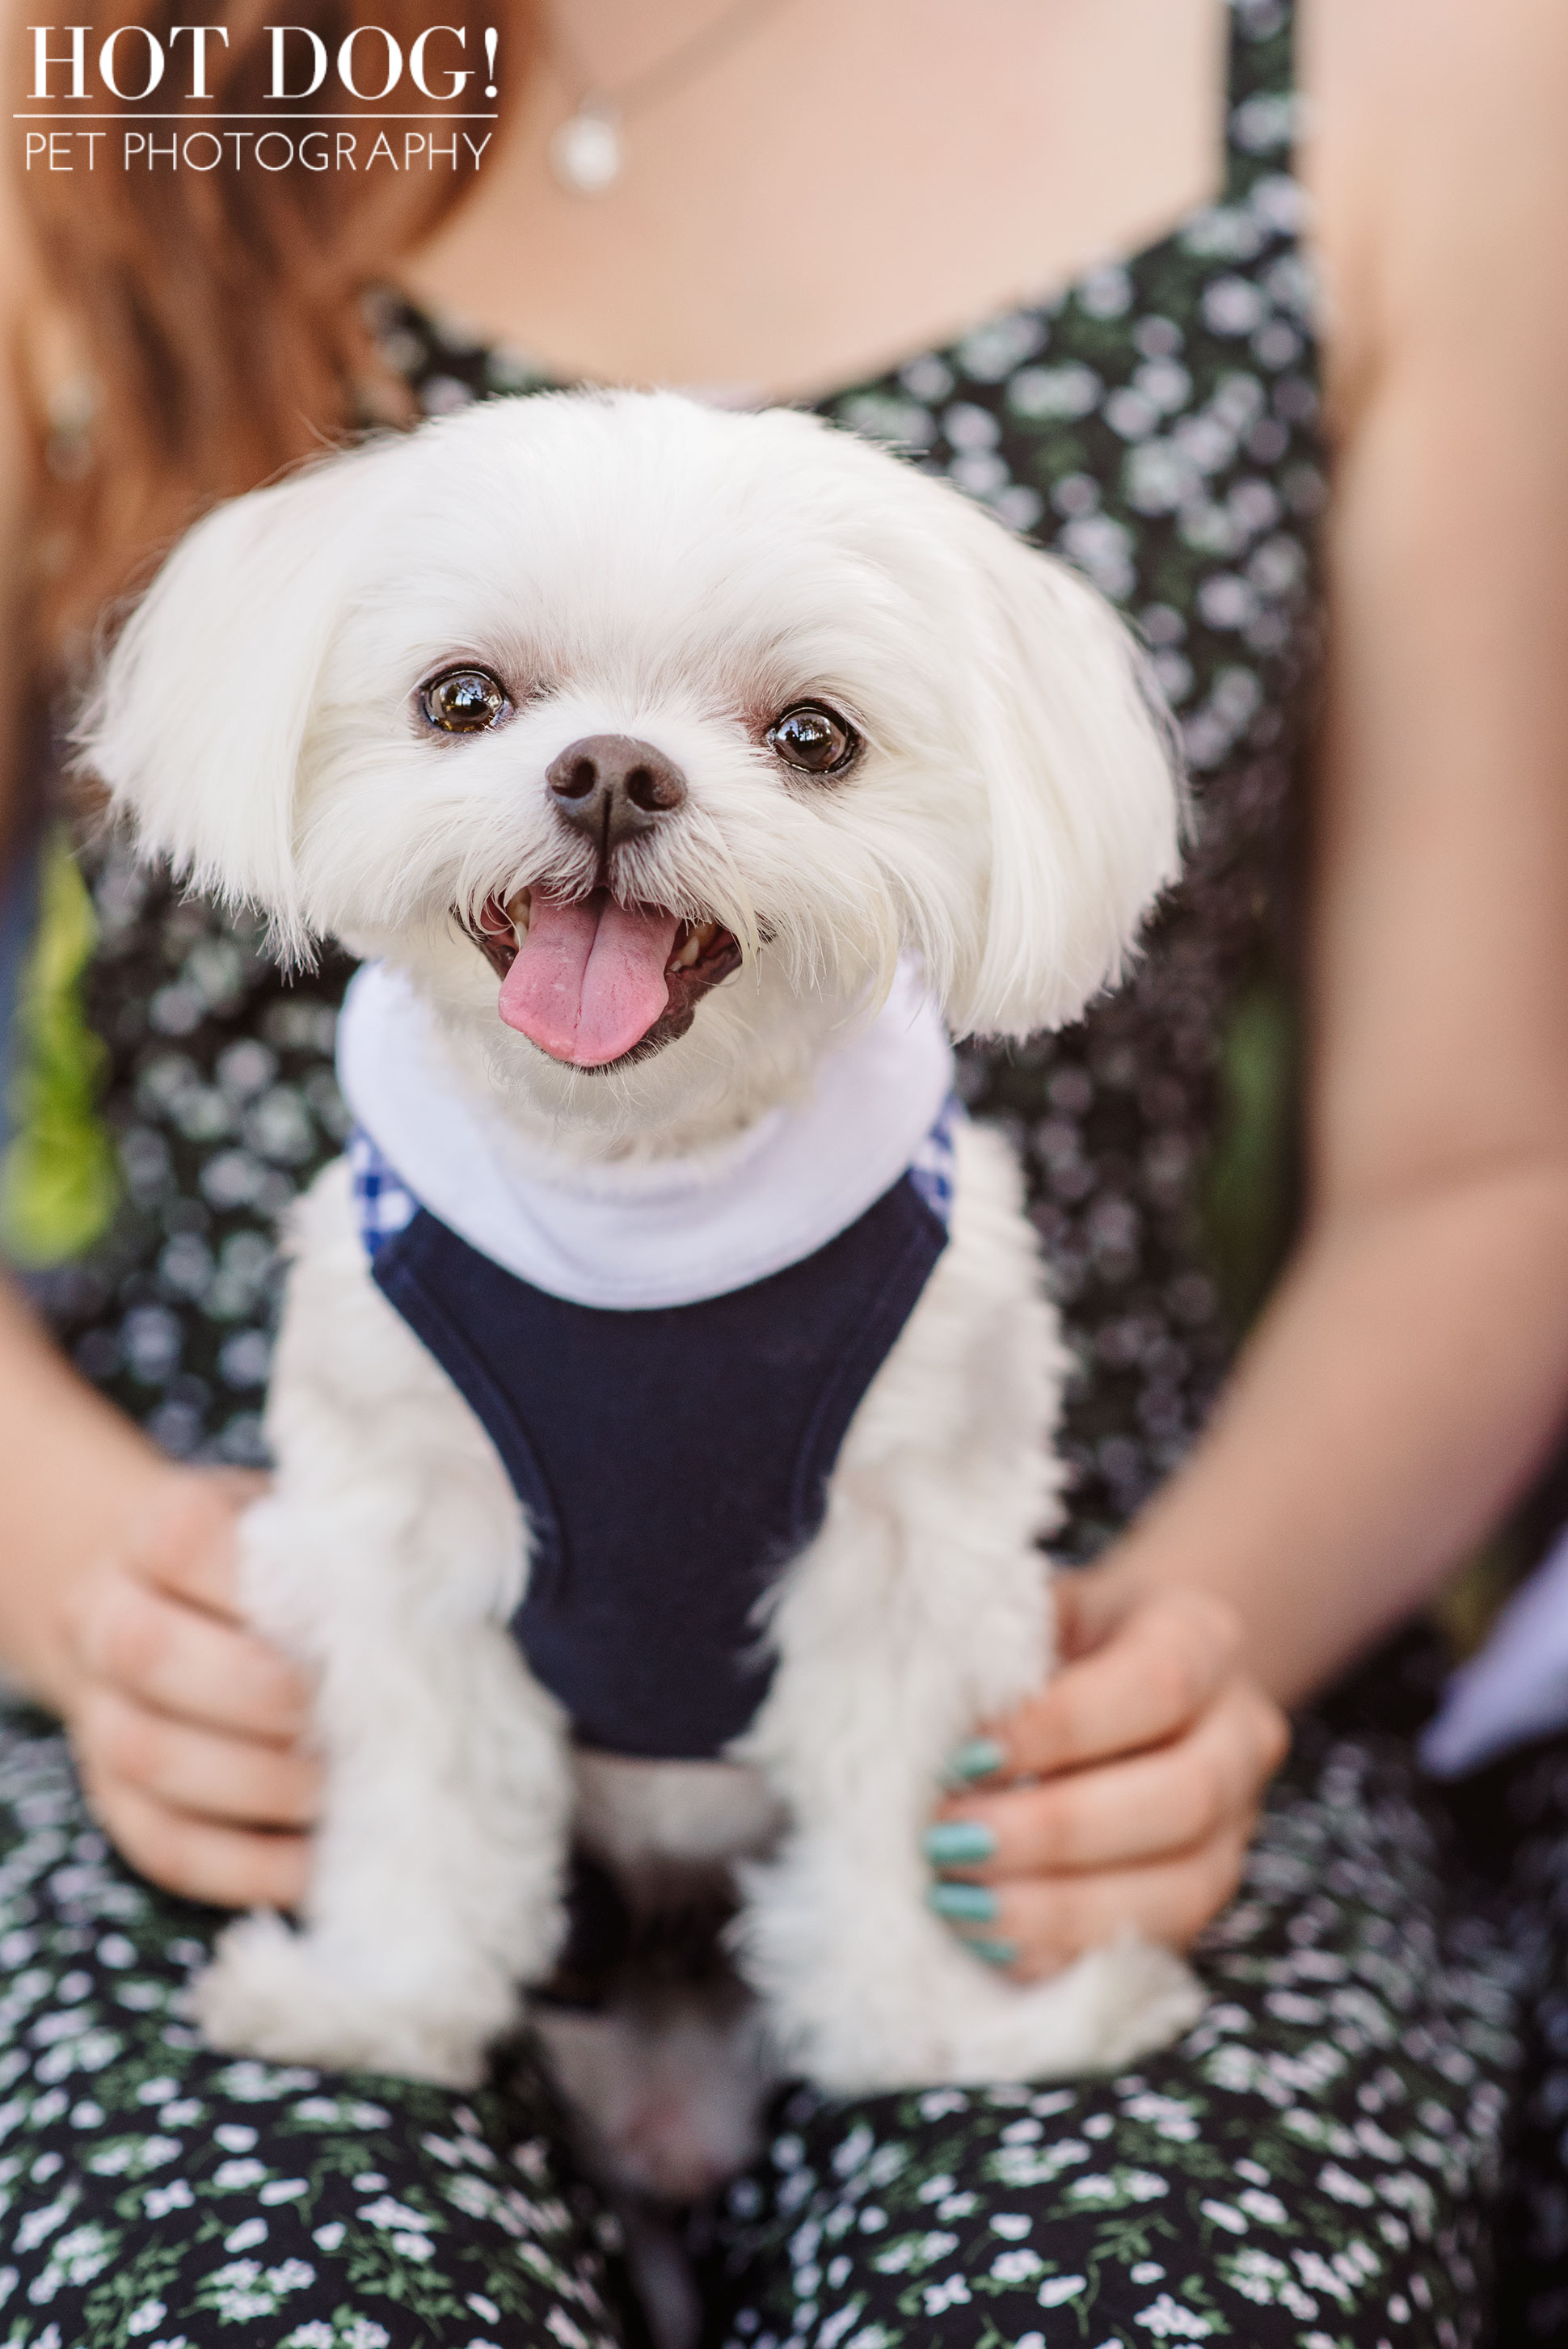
left=0, top=201, right=317, bottom=1905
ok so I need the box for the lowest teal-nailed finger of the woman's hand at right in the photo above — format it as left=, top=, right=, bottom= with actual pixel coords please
left=932, top=1828, right=1249, bottom=1980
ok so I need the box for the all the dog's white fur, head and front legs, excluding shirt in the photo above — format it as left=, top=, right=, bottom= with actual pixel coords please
left=85, top=394, right=1195, bottom=2090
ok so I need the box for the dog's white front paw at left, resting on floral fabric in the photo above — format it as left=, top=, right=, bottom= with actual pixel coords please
left=192, top=1912, right=504, bottom=2088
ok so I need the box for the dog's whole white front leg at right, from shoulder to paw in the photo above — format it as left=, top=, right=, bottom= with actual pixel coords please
left=732, top=1135, right=1199, bottom=2093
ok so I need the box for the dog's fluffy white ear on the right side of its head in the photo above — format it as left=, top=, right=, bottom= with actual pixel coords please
left=946, top=512, right=1186, bottom=1036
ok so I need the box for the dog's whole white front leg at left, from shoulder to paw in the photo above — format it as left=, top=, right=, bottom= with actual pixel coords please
left=195, top=1167, right=571, bottom=2086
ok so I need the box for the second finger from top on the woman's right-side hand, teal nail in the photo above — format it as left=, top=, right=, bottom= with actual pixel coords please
left=927, top=1682, right=1288, bottom=1882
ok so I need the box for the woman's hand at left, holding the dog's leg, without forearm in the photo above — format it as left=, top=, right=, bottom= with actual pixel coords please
left=57, top=1470, right=322, bottom=1908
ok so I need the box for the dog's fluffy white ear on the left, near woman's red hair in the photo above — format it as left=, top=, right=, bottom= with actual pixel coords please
left=75, top=449, right=380, bottom=951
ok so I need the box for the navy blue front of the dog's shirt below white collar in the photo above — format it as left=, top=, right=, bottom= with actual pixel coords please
left=355, top=1137, right=946, bottom=1760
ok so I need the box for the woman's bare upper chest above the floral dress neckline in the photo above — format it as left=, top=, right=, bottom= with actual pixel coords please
left=392, top=0, right=1225, bottom=397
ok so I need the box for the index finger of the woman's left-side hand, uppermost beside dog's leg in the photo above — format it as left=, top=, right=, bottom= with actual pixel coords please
left=78, top=1571, right=310, bottom=1743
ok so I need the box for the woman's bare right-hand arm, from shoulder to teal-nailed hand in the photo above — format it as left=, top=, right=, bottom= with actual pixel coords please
left=943, top=0, right=1568, bottom=1971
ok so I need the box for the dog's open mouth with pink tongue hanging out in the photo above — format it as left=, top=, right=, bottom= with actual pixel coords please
left=465, top=888, right=740, bottom=1069
